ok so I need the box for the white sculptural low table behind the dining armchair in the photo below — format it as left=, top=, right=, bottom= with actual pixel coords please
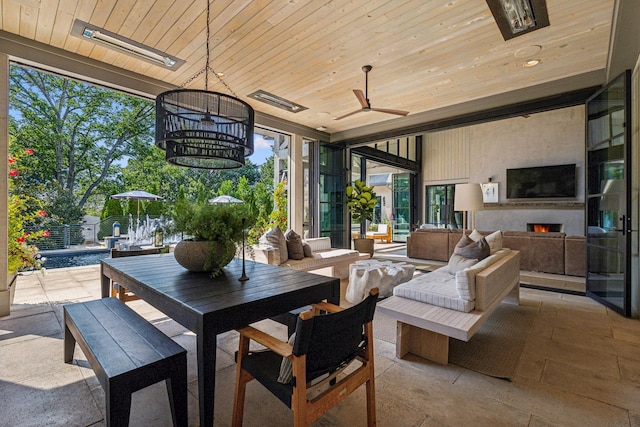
left=345, top=259, right=416, bottom=304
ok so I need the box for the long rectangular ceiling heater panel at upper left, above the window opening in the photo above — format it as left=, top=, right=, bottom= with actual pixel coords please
left=71, top=19, right=185, bottom=71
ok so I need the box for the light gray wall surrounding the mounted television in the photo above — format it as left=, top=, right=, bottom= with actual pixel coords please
left=424, top=106, right=585, bottom=236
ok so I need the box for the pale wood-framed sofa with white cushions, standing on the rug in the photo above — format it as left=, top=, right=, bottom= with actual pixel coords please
left=378, top=235, right=520, bottom=365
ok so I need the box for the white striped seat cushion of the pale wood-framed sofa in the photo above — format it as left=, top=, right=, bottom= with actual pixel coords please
left=393, top=266, right=475, bottom=313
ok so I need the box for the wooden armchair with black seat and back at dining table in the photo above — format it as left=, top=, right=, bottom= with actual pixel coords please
left=232, top=288, right=378, bottom=427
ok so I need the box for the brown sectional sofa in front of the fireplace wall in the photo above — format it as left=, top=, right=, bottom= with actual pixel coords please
left=407, top=228, right=586, bottom=277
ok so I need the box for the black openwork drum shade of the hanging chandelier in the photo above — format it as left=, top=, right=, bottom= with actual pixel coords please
left=156, top=89, right=254, bottom=169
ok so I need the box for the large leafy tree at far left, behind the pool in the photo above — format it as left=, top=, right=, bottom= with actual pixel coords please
left=9, top=66, right=154, bottom=223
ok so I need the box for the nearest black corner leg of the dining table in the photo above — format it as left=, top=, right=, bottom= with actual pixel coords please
left=197, top=331, right=217, bottom=426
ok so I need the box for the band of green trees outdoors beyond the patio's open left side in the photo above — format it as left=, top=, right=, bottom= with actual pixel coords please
left=9, top=66, right=286, bottom=240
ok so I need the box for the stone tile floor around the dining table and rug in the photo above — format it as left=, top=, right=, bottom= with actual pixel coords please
left=0, top=266, right=640, bottom=427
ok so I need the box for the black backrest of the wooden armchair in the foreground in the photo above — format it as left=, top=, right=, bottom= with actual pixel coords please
left=293, top=293, right=378, bottom=381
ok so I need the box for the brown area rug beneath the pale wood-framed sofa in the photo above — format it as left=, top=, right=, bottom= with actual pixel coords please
left=449, top=304, right=537, bottom=381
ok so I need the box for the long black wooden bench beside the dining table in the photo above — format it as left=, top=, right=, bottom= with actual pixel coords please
left=64, top=298, right=188, bottom=426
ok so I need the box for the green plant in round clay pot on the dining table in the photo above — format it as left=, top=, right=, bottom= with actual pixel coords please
left=173, top=201, right=253, bottom=276
